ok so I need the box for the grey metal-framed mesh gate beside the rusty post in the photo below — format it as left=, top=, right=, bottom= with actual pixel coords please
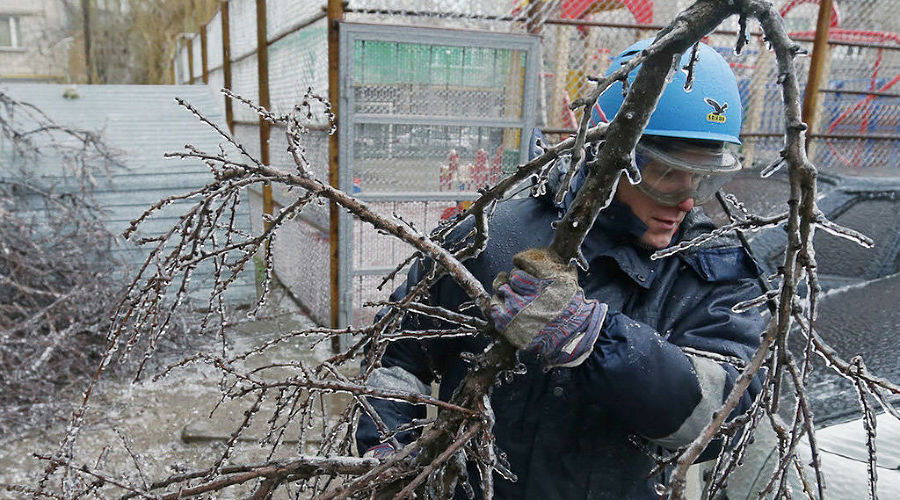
left=338, top=23, right=540, bottom=325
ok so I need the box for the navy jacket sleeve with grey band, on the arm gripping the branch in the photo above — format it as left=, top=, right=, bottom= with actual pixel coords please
left=573, top=279, right=763, bottom=449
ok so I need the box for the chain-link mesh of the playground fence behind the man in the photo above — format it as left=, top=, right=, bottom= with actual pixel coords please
left=173, top=0, right=900, bottom=323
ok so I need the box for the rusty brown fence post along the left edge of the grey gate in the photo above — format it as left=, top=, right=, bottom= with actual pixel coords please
left=328, top=0, right=345, bottom=340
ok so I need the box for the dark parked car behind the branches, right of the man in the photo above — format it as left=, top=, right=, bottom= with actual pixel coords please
left=732, top=170, right=900, bottom=425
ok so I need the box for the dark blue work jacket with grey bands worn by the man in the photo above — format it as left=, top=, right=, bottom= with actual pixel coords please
left=357, top=186, right=764, bottom=500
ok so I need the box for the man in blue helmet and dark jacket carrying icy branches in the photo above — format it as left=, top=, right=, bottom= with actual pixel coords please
left=357, top=40, right=763, bottom=499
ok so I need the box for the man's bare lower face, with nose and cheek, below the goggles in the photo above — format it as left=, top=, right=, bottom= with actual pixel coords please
left=616, top=180, right=694, bottom=248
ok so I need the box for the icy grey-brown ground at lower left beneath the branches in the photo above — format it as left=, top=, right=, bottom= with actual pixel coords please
left=0, top=302, right=344, bottom=499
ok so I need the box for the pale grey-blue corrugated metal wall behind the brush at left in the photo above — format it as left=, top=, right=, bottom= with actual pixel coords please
left=0, top=84, right=256, bottom=306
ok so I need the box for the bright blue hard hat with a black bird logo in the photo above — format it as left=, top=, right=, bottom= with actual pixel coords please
left=591, top=38, right=742, bottom=144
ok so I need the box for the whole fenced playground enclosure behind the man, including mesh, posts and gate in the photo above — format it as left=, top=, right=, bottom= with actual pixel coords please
left=174, top=0, right=900, bottom=326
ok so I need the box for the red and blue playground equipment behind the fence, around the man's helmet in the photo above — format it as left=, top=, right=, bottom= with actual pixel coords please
left=545, top=0, right=900, bottom=170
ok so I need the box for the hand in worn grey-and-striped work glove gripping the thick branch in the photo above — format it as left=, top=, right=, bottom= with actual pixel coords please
left=491, top=248, right=608, bottom=369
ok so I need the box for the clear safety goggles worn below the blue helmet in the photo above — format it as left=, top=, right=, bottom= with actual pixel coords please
left=635, top=139, right=741, bottom=206
